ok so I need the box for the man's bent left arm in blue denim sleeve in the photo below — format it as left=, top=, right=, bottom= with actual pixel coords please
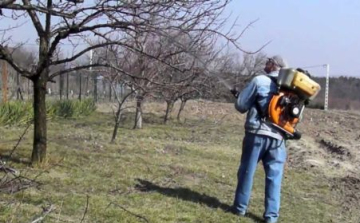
left=235, top=78, right=257, bottom=113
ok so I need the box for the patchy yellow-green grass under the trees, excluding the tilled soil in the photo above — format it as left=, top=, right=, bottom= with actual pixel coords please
left=0, top=104, right=354, bottom=223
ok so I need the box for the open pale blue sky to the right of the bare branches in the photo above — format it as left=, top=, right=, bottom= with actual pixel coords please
left=226, top=0, right=360, bottom=77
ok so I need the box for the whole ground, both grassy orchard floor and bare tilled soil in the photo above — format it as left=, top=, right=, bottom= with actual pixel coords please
left=0, top=100, right=360, bottom=223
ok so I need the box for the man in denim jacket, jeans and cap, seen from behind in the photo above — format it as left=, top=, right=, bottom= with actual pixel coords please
left=232, top=56, right=286, bottom=223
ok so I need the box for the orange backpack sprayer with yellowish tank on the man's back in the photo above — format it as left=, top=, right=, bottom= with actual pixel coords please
left=265, top=68, right=321, bottom=139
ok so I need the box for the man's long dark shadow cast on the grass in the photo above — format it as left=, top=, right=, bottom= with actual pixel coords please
left=135, top=179, right=263, bottom=222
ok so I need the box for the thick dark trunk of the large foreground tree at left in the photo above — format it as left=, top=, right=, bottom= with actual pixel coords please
left=31, top=76, right=47, bottom=164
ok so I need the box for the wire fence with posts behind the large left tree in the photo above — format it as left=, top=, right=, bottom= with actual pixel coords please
left=0, top=62, right=127, bottom=102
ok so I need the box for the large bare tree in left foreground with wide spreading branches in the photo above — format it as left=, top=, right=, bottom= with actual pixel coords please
left=0, top=0, right=253, bottom=163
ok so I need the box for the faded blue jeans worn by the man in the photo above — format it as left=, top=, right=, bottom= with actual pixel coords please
left=233, top=133, right=286, bottom=222
